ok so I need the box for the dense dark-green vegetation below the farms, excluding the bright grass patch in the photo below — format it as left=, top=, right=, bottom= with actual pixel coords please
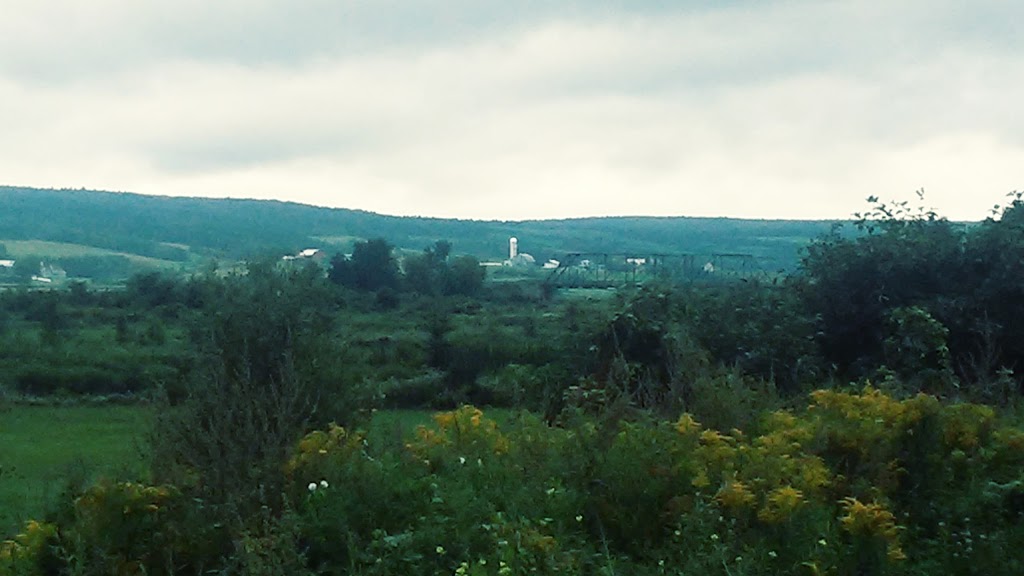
left=6, top=196, right=1024, bottom=576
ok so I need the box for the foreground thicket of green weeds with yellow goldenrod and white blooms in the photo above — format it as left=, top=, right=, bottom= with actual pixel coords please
left=8, top=387, right=1024, bottom=575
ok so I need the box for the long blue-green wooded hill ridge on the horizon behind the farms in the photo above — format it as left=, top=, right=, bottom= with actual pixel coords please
left=0, top=187, right=833, bottom=273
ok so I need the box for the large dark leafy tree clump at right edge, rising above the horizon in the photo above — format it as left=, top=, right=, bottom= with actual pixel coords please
left=799, top=194, right=1024, bottom=400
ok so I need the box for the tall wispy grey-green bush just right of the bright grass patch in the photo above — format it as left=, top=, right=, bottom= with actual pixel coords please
left=153, top=260, right=343, bottom=523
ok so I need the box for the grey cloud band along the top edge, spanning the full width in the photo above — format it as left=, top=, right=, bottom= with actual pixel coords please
left=14, top=0, right=1024, bottom=83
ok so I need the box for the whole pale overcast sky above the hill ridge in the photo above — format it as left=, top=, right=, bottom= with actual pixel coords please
left=0, top=0, right=1024, bottom=219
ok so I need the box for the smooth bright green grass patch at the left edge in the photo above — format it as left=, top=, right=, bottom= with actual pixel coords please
left=0, top=406, right=150, bottom=535
